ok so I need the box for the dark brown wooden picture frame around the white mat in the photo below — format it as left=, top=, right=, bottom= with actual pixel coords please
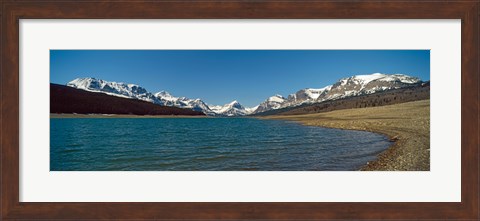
left=0, top=0, right=480, bottom=220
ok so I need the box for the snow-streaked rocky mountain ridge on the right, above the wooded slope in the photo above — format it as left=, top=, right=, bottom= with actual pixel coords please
left=253, top=73, right=422, bottom=114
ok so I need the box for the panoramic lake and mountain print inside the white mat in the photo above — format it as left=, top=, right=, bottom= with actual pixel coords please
left=50, top=50, right=430, bottom=171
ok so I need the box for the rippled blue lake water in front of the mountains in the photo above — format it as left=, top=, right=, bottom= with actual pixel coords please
left=50, top=118, right=391, bottom=171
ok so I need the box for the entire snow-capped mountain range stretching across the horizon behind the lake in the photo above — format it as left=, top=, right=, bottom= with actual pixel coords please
left=67, top=73, right=422, bottom=116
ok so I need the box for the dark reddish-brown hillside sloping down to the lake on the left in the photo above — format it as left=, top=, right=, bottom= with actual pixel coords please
left=50, top=84, right=205, bottom=115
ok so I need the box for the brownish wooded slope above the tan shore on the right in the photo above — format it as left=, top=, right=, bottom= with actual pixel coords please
left=255, top=82, right=430, bottom=116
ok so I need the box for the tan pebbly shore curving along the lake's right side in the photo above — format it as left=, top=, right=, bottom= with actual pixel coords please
left=259, top=99, right=430, bottom=171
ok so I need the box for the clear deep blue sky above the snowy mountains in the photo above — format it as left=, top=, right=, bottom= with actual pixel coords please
left=50, top=50, right=430, bottom=107
